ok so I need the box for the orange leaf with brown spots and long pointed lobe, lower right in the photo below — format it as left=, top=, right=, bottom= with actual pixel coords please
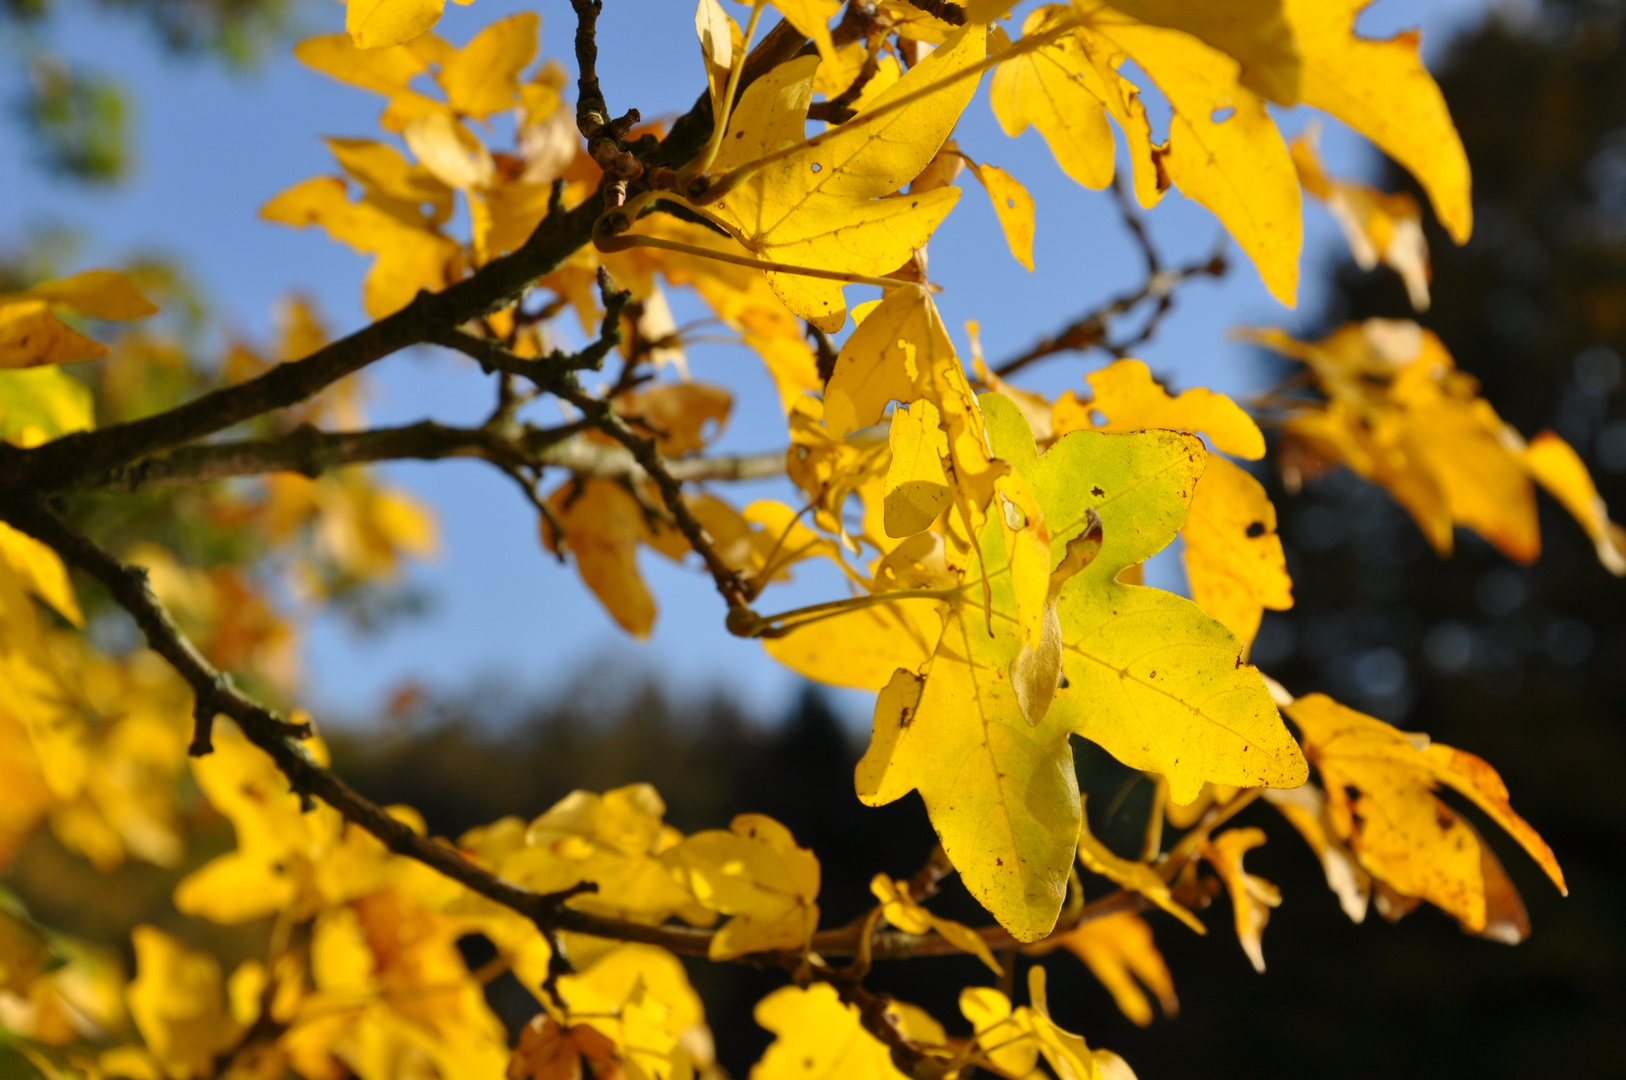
left=1286, top=695, right=1566, bottom=934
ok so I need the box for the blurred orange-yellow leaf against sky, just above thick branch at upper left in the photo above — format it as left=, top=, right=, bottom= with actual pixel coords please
left=260, top=176, right=459, bottom=319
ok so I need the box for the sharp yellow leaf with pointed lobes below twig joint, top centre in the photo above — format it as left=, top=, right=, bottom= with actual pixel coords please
left=707, top=26, right=984, bottom=332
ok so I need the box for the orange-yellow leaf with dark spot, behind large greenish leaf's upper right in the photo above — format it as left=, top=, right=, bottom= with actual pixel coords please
left=1180, top=457, right=1293, bottom=644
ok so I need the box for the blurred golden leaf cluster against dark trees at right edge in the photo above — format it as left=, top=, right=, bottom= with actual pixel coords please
left=1246, top=319, right=1626, bottom=576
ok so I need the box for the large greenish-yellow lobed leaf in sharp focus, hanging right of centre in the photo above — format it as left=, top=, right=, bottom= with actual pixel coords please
left=855, top=394, right=1306, bottom=940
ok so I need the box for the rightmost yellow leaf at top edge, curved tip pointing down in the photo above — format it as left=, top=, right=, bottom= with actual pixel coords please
left=1283, top=0, right=1473, bottom=244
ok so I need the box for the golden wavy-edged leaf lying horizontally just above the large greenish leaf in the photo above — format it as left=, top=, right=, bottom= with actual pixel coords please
left=1052, top=359, right=1265, bottom=459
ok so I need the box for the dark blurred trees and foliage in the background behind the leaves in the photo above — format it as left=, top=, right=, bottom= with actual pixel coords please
left=9, top=0, right=1626, bottom=1080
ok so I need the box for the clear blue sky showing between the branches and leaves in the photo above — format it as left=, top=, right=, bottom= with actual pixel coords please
left=0, top=0, right=1485, bottom=724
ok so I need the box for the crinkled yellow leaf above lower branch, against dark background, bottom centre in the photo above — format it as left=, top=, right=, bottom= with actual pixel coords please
left=662, top=813, right=820, bottom=960
